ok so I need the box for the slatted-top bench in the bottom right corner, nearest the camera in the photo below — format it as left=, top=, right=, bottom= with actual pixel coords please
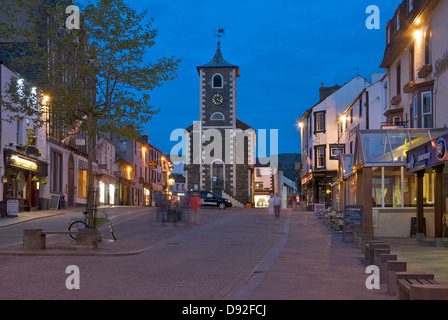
left=396, top=272, right=448, bottom=300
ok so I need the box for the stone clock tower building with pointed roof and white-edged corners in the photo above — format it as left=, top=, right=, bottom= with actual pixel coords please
left=185, top=42, right=255, bottom=206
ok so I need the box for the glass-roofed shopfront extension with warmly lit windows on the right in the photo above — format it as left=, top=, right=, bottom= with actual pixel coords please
left=340, top=129, right=448, bottom=237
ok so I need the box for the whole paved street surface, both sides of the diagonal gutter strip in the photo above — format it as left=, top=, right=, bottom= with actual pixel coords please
left=0, top=208, right=394, bottom=300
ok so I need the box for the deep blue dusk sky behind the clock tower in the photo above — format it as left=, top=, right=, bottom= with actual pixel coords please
left=101, top=0, right=401, bottom=155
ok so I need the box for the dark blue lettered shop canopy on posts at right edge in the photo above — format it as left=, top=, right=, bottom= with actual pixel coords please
left=406, top=133, right=448, bottom=244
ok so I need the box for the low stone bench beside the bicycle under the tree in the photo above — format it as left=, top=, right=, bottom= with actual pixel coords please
left=23, top=229, right=98, bottom=250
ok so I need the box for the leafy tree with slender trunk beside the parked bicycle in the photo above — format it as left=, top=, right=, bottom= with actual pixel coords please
left=0, top=0, right=180, bottom=227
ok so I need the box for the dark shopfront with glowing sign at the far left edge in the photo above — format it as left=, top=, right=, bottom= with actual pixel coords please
left=2, top=149, right=48, bottom=211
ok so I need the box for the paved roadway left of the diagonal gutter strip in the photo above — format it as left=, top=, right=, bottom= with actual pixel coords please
left=0, top=209, right=284, bottom=299
